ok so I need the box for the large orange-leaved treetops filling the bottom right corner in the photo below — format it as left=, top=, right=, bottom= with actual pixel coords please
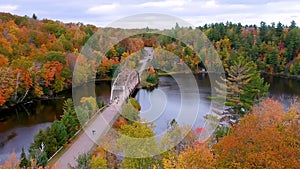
left=214, top=99, right=300, bottom=168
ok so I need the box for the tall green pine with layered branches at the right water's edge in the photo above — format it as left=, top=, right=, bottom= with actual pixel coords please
left=226, top=56, right=269, bottom=114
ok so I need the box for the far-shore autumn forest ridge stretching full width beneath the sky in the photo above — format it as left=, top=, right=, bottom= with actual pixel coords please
left=0, top=13, right=300, bottom=108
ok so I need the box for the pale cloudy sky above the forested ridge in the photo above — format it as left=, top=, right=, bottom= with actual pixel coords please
left=0, top=0, right=300, bottom=27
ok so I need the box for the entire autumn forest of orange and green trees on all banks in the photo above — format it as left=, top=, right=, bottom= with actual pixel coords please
left=0, top=13, right=300, bottom=169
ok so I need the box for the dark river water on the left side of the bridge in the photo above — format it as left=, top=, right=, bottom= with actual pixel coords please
left=0, top=81, right=111, bottom=164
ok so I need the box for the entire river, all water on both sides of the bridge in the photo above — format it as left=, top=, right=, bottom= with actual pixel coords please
left=0, top=74, right=300, bottom=164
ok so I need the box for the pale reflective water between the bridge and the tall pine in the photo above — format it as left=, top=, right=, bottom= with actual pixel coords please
left=135, top=74, right=211, bottom=135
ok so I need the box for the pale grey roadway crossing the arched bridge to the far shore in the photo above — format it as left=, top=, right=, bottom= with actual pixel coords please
left=52, top=48, right=153, bottom=169
